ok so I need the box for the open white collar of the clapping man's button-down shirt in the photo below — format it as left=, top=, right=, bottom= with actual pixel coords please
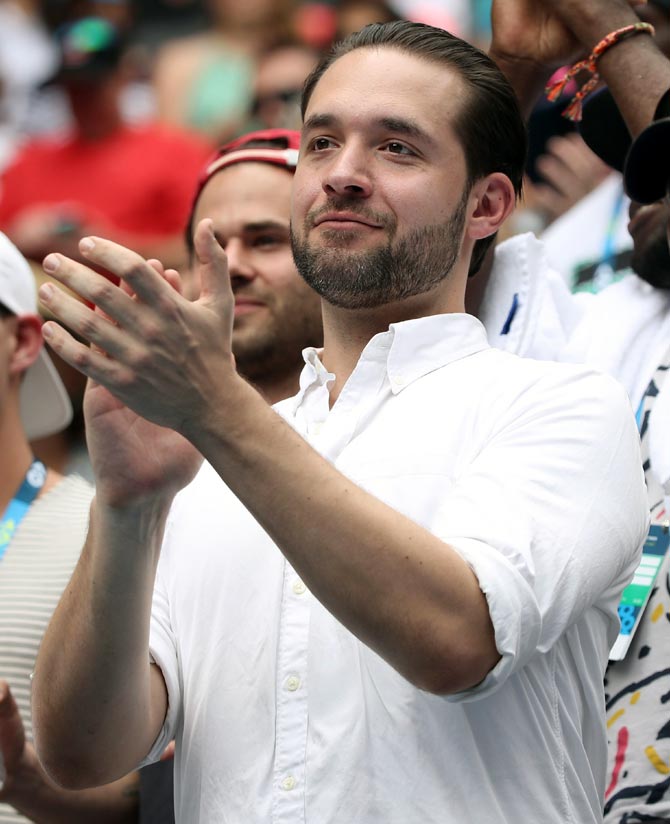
left=292, top=313, right=490, bottom=413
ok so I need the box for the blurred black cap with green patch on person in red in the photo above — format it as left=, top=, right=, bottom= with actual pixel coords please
left=44, top=17, right=123, bottom=85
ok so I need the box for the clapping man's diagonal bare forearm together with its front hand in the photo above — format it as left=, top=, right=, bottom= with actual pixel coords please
left=32, top=221, right=643, bottom=720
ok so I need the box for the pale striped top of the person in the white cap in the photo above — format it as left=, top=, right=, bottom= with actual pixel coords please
left=0, top=475, right=93, bottom=824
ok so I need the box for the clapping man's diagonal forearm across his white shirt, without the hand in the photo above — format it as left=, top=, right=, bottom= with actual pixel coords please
left=185, top=384, right=499, bottom=693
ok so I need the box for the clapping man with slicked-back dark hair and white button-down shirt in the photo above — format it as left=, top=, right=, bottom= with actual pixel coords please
left=34, top=14, right=646, bottom=824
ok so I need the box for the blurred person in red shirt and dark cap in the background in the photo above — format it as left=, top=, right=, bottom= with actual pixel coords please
left=0, top=18, right=211, bottom=265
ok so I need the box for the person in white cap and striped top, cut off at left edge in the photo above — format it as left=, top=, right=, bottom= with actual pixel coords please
left=0, top=234, right=137, bottom=824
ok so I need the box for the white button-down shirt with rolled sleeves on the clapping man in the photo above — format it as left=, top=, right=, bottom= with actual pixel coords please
left=144, top=315, right=647, bottom=824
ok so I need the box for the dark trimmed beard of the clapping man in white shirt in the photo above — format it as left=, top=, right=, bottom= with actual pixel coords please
left=291, top=186, right=470, bottom=309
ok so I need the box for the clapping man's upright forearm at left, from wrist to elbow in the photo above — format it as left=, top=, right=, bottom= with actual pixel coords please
left=33, top=501, right=167, bottom=789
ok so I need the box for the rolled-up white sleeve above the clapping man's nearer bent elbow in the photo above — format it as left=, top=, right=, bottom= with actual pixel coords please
left=433, top=370, right=649, bottom=701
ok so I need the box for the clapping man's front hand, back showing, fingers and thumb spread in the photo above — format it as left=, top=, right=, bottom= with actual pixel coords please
left=40, top=220, right=242, bottom=432
